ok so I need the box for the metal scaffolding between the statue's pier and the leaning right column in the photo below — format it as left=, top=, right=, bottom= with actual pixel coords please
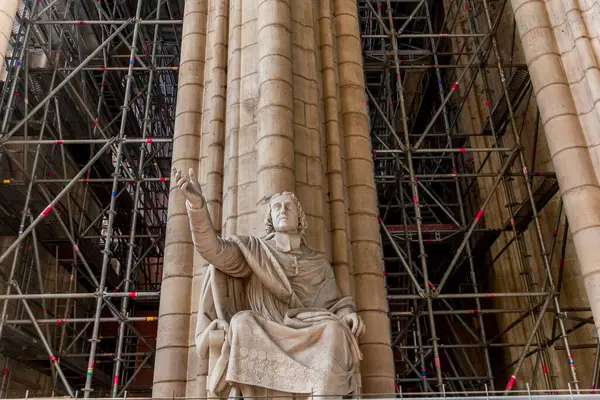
left=358, top=0, right=598, bottom=393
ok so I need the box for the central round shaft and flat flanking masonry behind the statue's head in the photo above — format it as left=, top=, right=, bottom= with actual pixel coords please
left=223, top=0, right=330, bottom=252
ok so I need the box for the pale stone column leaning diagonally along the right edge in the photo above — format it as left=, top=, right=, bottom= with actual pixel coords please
left=512, top=0, right=600, bottom=329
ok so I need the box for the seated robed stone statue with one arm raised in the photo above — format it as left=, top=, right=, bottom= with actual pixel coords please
left=174, top=170, right=365, bottom=398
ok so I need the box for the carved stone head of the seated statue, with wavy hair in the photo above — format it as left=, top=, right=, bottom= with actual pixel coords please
left=265, top=192, right=308, bottom=235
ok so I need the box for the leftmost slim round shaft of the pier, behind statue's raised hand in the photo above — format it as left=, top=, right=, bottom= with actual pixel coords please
left=152, top=0, right=207, bottom=397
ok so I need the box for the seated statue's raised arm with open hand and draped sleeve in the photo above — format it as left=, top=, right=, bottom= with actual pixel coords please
left=173, top=168, right=251, bottom=277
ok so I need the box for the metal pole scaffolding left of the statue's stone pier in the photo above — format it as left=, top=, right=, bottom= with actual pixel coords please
left=0, top=0, right=182, bottom=398
